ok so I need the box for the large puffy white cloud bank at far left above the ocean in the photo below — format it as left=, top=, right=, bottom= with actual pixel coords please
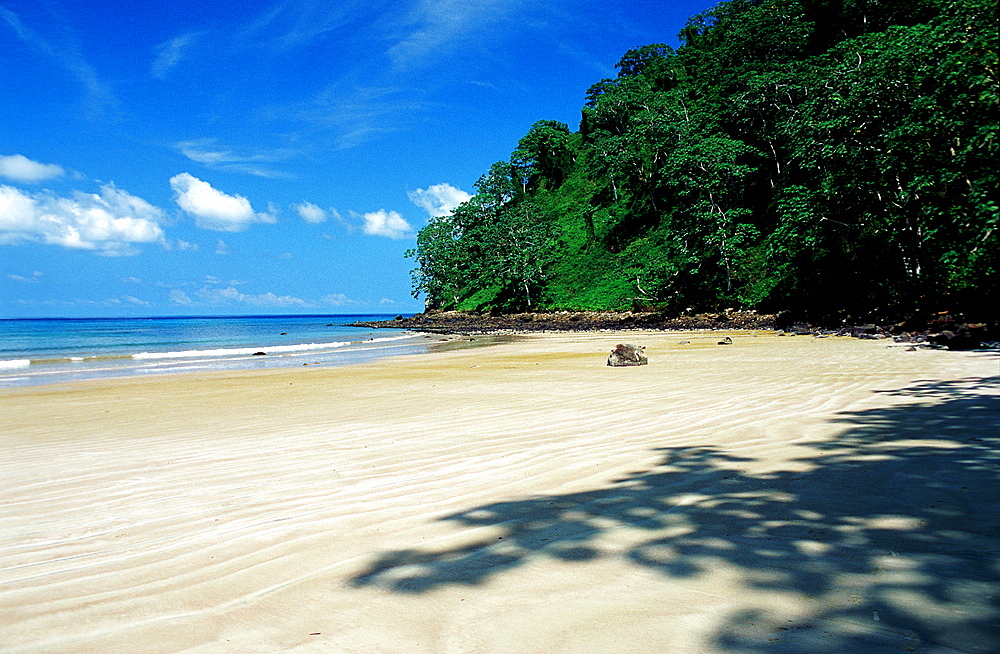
left=0, top=184, right=166, bottom=255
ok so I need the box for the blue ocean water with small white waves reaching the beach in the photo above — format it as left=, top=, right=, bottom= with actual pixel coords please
left=0, top=315, right=431, bottom=388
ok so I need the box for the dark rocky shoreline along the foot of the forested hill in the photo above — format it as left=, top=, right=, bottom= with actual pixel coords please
left=353, top=311, right=1000, bottom=350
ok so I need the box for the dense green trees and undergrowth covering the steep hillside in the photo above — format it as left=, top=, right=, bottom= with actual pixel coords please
left=411, top=0, right=1000, bottom=319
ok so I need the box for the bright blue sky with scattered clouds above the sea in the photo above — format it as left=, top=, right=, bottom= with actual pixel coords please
left=0, top=0, right=713, bottom=317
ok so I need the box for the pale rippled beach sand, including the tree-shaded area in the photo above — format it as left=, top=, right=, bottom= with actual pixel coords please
left=0, top=332, right=1000, bottom=654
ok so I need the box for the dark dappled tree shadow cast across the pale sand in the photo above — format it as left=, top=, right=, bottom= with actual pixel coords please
left=351, top=378, right=1000, bottom=653
